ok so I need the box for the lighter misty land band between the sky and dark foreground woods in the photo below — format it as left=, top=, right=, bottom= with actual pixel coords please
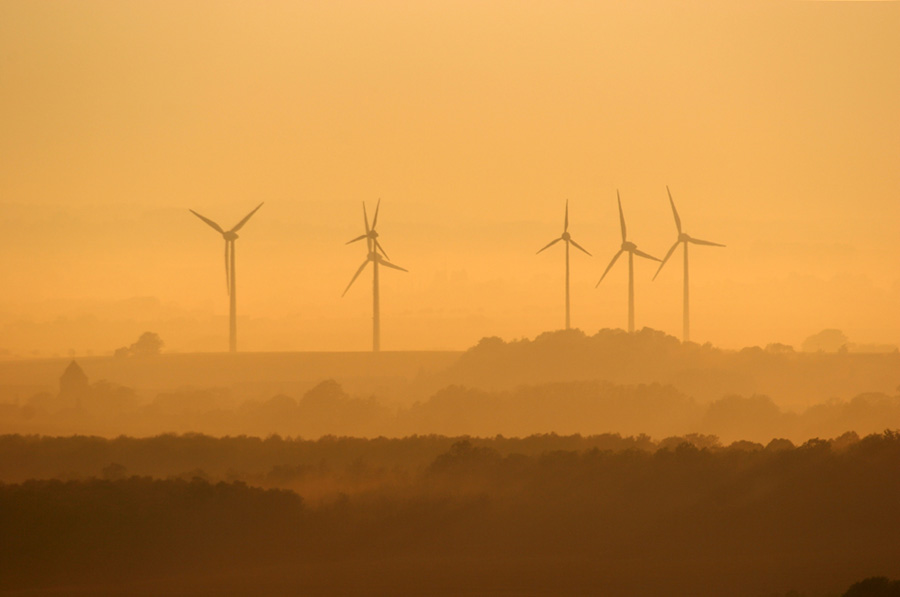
left=0, top=329, right=900, bottom=442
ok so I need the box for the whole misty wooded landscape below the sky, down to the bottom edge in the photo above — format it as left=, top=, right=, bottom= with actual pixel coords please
left=0, top=329, right=900, bottom=597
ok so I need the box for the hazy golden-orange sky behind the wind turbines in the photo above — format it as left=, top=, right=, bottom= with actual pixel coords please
left=0, top=0, right=900, bottom=354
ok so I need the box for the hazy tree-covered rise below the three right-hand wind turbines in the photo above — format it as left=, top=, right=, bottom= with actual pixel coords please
left=440, top=328, right=900, bottom=407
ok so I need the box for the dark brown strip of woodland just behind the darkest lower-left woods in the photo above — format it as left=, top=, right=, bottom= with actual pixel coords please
left=0, top=433, right=684, bottom=484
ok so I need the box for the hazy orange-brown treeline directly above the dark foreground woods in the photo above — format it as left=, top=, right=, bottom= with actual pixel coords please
left=0, top=380, right=900, bottom=442
